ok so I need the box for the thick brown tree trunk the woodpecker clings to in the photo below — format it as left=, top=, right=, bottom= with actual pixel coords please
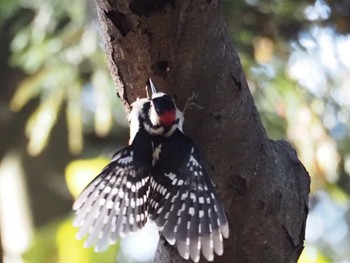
left=97, top=0, right=310, bottom=263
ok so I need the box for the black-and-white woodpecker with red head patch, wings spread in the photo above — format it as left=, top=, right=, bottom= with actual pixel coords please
left=73, top=80, right=229, bottom=262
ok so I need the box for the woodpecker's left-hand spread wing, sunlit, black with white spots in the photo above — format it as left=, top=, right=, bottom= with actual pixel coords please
left=73, top=129, right=152, bottom=251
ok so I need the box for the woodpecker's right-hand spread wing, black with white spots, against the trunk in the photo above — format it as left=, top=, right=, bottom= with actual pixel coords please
left=149, top=130, right=229, bottom=262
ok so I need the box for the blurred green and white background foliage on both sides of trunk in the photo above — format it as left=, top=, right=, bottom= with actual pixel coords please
left=0, top=0, right=350, bottom=263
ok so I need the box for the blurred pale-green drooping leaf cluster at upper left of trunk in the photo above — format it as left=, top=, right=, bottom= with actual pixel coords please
left=6, top=0, right=119, bottom=155
